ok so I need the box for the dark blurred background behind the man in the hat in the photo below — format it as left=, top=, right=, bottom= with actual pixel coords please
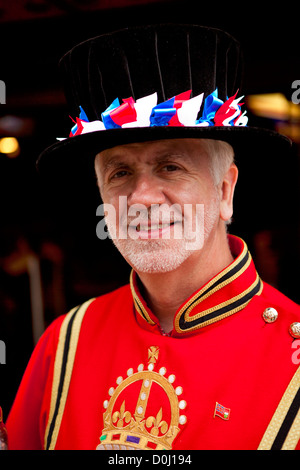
left=0, top=0, right=300, bottom=419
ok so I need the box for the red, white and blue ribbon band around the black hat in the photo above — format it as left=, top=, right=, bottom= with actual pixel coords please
left=58, top=89, right=248, bottom=140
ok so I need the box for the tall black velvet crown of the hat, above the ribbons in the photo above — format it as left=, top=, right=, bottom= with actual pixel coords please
left=60, top=24, right=241, bottom=120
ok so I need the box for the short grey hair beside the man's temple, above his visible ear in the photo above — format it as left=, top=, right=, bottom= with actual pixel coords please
left=202, top=139, right=234, bottom=187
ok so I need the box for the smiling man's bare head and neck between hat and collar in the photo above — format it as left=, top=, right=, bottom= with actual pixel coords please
left=96, top=139, right=237, bottom=332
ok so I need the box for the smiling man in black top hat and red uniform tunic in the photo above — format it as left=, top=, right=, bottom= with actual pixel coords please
left=7, top=25, right=300, bottom=450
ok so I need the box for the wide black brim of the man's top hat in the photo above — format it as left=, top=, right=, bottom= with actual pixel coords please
left=37, top=126, right=291, bottom=181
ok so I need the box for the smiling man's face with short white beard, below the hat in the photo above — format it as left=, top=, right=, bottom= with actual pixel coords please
left=95, top=139, right=227, bottom=272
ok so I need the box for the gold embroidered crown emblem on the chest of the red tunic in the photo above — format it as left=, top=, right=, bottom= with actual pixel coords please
left=97, top=346, right=186, bottom=450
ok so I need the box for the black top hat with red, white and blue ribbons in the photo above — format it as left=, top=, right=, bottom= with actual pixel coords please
left=37, top=24, right=291, bottom=182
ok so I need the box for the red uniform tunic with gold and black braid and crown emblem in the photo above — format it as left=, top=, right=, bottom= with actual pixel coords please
left=6, top=236, right=300, bottom=450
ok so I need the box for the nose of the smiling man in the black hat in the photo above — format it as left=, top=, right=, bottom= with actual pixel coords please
left=128, top=174, right=166, bottom=207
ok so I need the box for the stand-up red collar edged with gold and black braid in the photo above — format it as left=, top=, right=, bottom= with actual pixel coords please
left=130, top=235, right=262, bottom=336
